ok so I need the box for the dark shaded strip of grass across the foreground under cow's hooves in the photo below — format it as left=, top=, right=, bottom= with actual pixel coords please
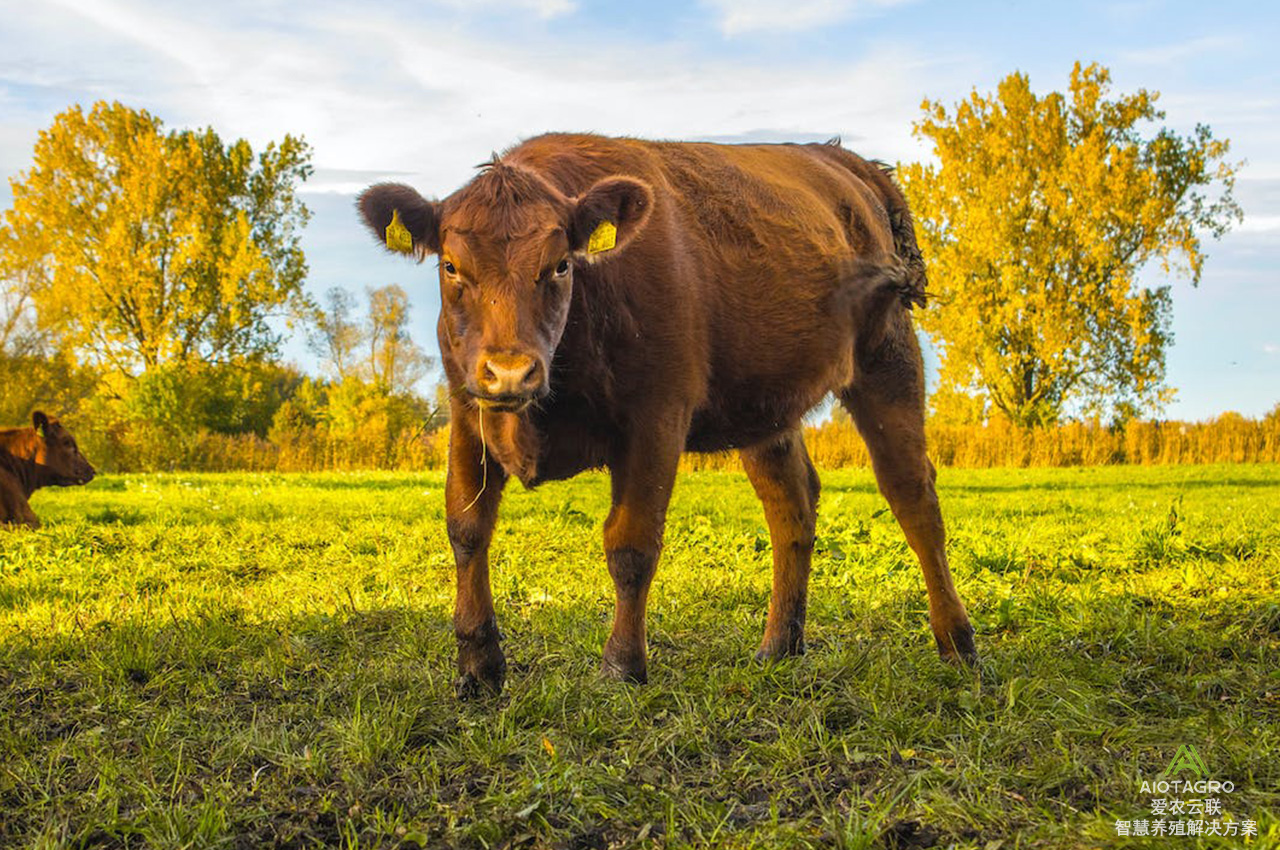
left=0, top=593, right=1280, bottom=847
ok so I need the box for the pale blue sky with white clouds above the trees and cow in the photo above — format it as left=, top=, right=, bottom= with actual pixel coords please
left=0, top=0, right=1280, bottom=419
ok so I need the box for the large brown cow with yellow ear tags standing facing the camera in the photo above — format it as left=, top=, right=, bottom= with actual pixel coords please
left=360, top=134, right=975, bottom=694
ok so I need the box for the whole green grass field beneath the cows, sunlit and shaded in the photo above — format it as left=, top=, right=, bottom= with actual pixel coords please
left=0, top=466, right=1280, bottom=850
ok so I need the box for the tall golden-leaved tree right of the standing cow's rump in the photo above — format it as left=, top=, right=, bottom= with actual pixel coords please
left=899, top=63, right=1242, bottom=425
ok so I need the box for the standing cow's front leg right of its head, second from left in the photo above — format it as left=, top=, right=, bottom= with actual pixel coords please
left=602, top=420, right=687, bottom=684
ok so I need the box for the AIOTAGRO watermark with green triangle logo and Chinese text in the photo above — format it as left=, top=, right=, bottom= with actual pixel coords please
left=1115, top=744, right=1258, bottom=836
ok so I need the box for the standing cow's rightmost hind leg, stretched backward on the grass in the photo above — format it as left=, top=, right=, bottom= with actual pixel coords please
left=841, top=323, right=978, bottom=664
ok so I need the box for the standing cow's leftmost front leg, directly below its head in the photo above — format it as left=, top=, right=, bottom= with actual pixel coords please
left=444, top=406, right=507, bottom=699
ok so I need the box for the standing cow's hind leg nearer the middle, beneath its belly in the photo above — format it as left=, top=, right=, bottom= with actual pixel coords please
left=740, top=430, right=819, bottom=659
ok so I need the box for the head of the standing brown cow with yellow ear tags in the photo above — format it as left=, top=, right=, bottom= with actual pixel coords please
left=360, top=160, right=653, bottom=411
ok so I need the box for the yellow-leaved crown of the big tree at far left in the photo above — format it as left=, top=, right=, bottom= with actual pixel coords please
left=0, top=102, right=311, bottom=378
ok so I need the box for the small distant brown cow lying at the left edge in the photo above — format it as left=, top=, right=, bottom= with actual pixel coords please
left=0, top=411, right=95, bottom=529
